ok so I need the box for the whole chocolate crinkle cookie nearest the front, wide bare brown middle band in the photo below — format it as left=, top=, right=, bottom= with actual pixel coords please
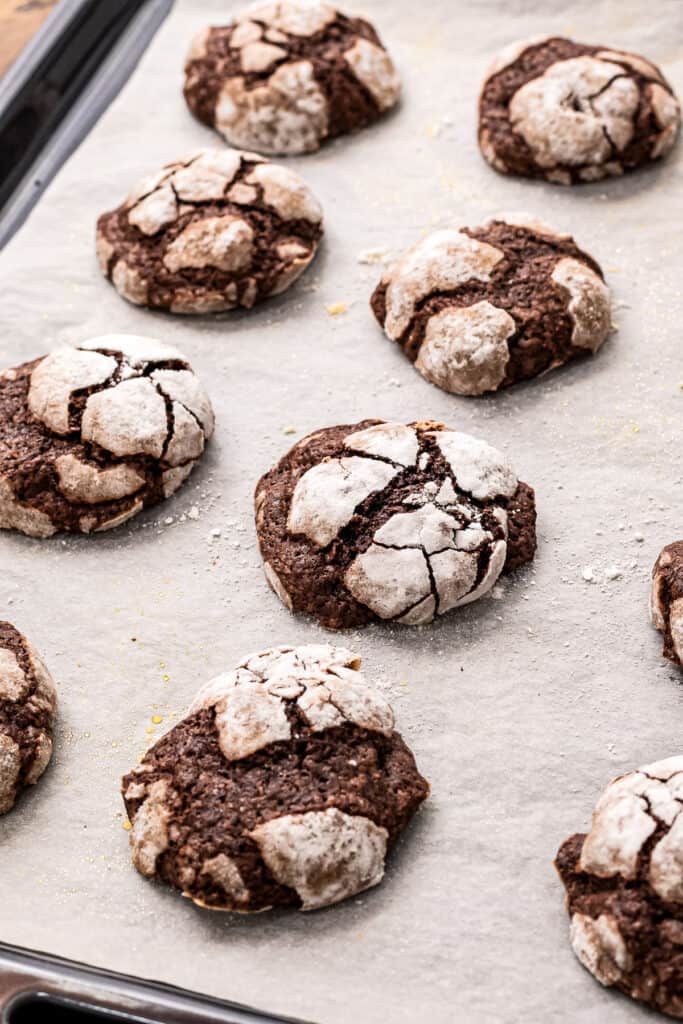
left=123, top=645, right=429, bottom=912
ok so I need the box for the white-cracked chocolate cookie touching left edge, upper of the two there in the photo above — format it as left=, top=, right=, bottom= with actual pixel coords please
left=0, top=334, right=214, bottom=537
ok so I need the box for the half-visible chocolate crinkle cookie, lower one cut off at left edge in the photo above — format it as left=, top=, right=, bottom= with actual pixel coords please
left=0, top=622, right=57, bottom=814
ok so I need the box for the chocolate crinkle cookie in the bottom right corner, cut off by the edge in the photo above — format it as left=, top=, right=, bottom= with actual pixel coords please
left=556, top=757, right=683, bottom=1018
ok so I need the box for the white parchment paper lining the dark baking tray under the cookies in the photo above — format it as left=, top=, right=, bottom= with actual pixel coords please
left=0, top=0, right=683, bottom=1024
